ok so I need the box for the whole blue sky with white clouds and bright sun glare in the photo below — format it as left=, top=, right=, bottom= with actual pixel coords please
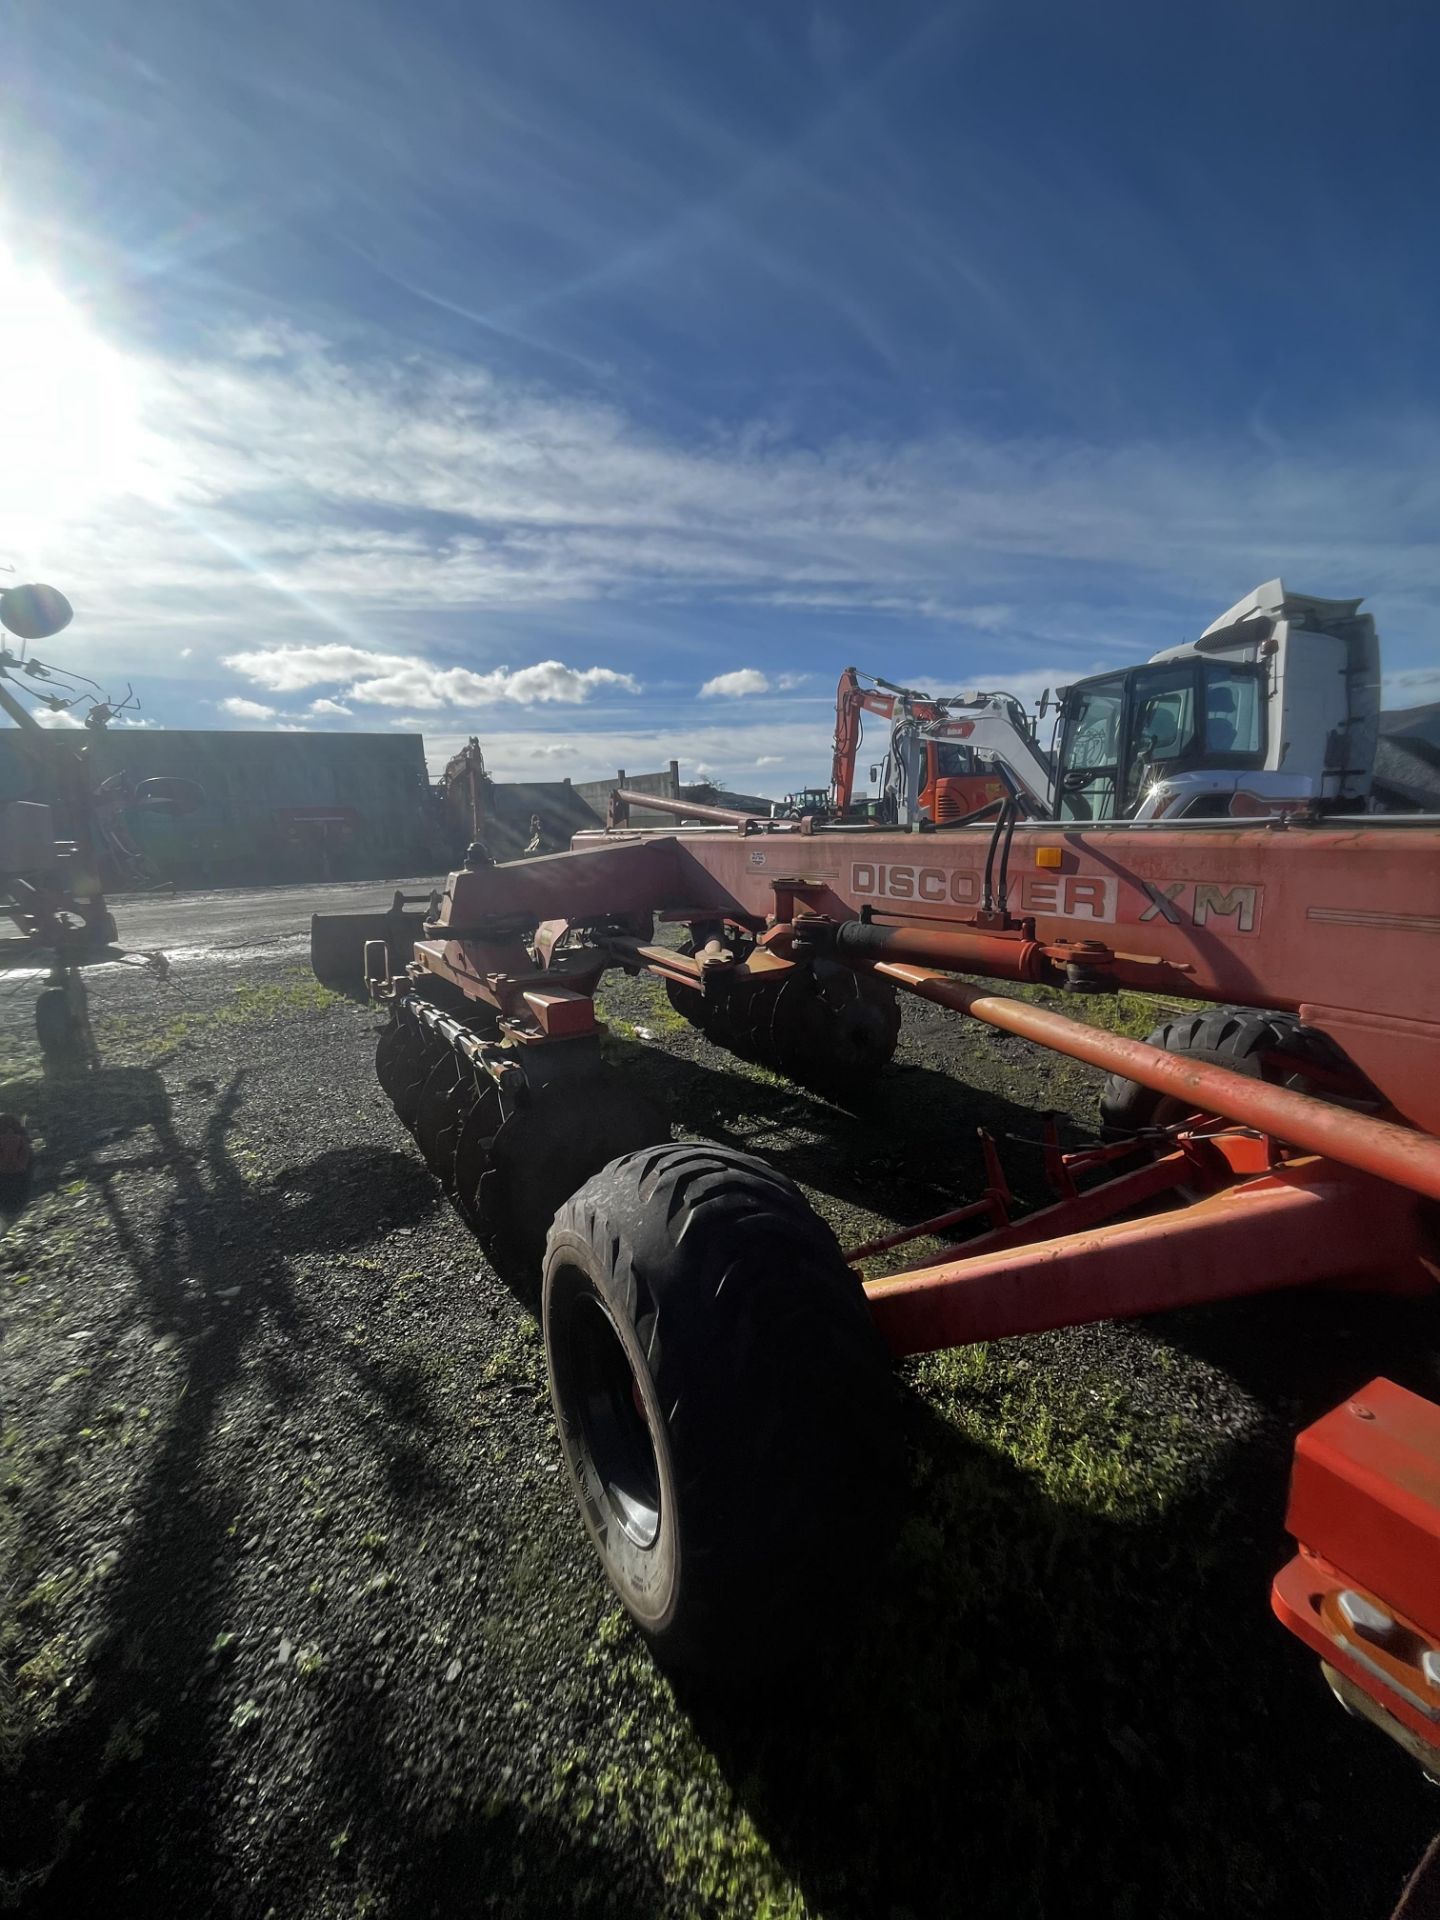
left=0, top=0, right=1440, bottom=791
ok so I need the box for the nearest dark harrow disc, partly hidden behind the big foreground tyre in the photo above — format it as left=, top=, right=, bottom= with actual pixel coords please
left=480, top=1077, right=670, bottom=1275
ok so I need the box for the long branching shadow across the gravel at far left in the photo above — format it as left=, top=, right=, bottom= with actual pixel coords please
left=0, top=1068, right=449, bottom=1914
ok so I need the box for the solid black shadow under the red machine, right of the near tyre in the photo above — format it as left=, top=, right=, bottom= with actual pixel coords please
left=682, top=1300, right=1440, bottom=1920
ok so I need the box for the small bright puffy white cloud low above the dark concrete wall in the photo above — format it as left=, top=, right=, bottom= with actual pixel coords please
left=223, top=643, right=639, bottom=712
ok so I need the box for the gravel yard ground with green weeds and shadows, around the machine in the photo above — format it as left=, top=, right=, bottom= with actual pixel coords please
left=0, top=889, right=1440, bottom=1920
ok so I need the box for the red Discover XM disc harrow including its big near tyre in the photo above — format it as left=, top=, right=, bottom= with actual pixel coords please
left=317, top=795, right=1440, bottom=1740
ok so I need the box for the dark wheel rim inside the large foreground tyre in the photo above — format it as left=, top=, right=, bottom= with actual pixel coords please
left=568, top=1294, right=660, bottom=1548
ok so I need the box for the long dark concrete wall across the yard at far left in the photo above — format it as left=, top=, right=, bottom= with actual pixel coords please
left=0, top=728, right=444, bottom=887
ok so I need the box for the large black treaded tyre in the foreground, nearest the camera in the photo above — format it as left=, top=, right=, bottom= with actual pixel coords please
left=543, top=1144, right=904, bottom=1674
